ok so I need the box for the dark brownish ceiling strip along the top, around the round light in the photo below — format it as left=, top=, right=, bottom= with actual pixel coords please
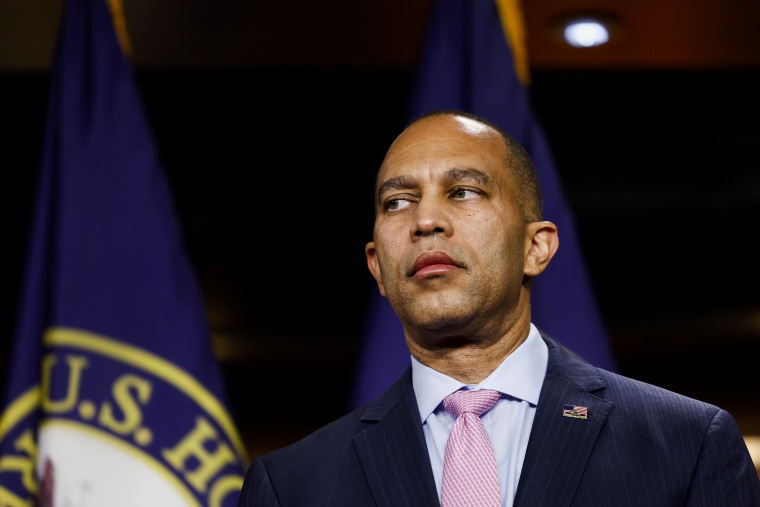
left=0, top=0, right=760, bottom=71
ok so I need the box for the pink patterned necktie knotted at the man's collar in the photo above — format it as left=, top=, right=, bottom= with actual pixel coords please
left=441, top=389, right=501, bottom=507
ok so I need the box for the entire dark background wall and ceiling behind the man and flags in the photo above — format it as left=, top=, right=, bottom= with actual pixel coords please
left=0, top=0, right=760, bottom=455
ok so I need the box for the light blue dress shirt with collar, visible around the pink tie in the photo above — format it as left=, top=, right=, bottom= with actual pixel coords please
left=412, top=324, right=549, bottom=507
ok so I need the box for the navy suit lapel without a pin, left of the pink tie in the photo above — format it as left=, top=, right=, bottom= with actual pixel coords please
left=354, top=368, right=440, bottom=507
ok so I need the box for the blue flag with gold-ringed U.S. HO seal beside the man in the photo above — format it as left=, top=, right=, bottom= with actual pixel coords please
left=0, top=0, right=247, bottom=507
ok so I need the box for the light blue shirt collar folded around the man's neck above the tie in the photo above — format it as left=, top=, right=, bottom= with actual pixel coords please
left=412, top=324, right=549, bottom=422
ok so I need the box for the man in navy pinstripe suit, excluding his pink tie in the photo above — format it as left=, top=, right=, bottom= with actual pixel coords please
left=239, top=112, right=760, bottom=507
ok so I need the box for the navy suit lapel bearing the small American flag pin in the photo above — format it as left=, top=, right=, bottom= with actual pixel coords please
left=514, top=339, right=612, bottom=507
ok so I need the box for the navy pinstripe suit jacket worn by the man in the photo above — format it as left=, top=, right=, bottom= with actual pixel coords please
left=238, top=337, right=760, bottom=507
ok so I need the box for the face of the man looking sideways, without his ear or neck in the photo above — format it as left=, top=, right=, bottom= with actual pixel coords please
left=366, top=115, right=531, bottom=342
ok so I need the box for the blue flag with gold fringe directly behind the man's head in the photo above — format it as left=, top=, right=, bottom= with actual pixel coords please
left=351, top=0, right=616, bottom=406
